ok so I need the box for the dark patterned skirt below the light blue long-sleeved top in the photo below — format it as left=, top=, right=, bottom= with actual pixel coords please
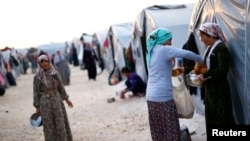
left=147, top=100, right=180, bottom=141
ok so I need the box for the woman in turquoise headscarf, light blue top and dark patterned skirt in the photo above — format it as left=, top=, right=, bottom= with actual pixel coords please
left=146, top=28, right=203, bottom=141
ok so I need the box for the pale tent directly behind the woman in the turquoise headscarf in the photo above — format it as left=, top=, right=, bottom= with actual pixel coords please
left=132, top=4, right=194, bottom=81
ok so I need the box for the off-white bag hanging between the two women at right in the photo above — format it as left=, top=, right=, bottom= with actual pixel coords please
left=172, top=74, right=194, bottom=119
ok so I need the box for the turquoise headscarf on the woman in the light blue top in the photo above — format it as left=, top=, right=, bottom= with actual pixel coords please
left=146, top=28, right=172, bottom=66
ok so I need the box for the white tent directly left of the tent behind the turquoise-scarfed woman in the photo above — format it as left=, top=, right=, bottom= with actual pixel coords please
left=106, top=22, right=133, bottom=85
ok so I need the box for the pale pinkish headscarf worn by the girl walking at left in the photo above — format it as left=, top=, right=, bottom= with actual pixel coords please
left=37, top=54, right=56, bottom=87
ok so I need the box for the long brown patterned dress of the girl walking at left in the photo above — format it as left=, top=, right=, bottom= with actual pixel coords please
left=33, top=72, right=73, bottom=141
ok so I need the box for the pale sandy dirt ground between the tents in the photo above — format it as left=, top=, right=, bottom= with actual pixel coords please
left=0, top=66, right=206, bottom=141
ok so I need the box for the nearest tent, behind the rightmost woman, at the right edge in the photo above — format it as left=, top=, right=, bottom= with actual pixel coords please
left=189, top=0, right=250, bottom=124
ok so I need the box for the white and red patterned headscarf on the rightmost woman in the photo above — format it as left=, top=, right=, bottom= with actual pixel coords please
left=199, top=22, right=225, bottom=42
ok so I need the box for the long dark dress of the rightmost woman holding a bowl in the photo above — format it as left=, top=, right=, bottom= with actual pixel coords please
left=203, top=43, right=235, bottom=131
